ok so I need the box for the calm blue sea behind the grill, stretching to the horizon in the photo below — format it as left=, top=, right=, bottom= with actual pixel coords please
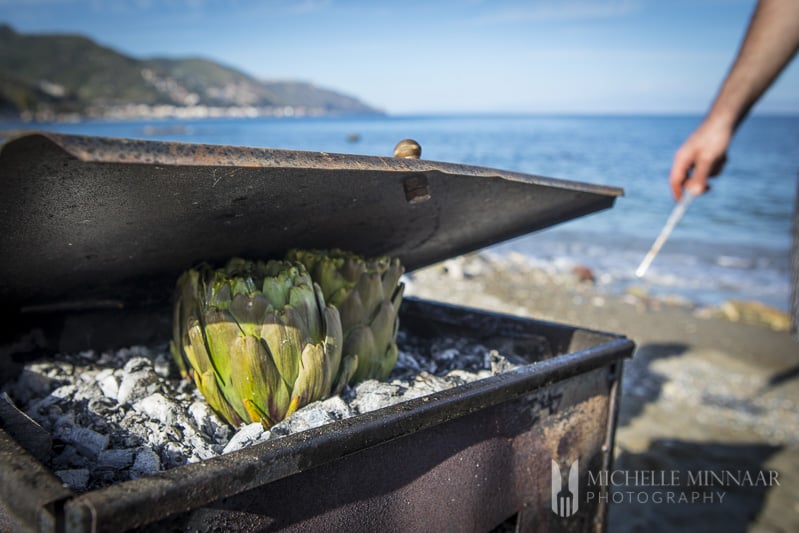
left=0, top=116, right=799, bottom=309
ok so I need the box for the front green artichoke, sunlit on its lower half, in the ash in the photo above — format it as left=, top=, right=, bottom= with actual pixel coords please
left=171, top=258, right=354, bottom=427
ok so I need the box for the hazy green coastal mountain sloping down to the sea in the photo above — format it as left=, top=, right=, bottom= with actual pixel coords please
left=0, top=24, right=380, bottom=119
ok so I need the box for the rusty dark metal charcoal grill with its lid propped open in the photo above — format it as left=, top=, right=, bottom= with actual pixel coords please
left=0, top=134, right=634, bottom=531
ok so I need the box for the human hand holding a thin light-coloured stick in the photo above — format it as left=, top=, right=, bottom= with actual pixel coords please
left=669, top=119, right=733, bottom=200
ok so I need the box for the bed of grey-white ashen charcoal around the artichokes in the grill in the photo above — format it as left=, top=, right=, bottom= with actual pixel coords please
left=3, top=331, right=524, bottom=492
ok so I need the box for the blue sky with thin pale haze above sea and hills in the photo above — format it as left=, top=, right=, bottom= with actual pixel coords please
left=0, top=0, right=799, bottom=114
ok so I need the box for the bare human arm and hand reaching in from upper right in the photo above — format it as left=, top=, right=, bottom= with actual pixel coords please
left=669, top=0, right=799, bottom=200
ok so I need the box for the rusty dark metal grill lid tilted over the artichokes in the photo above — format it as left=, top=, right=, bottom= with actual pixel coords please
left=0, top=133, right=623, bottom=310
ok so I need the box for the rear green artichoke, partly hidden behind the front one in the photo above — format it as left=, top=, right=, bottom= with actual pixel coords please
left=287, top=249, right=405, bottom=383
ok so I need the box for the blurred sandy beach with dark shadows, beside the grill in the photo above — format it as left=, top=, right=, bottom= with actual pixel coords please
left=407, top=255, right=799, bottom=532
